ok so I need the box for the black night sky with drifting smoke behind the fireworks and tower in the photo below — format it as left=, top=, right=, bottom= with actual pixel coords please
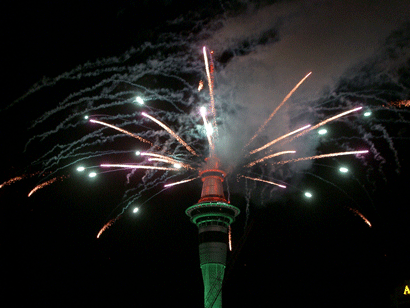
left=0, top=0, right=410, bottom=307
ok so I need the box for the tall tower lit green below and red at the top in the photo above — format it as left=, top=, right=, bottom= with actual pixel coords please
left=185, top=157, right=240, bottom=308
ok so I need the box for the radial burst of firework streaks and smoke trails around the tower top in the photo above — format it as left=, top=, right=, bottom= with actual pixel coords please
left=10, top=13, right=410, bottom=241
